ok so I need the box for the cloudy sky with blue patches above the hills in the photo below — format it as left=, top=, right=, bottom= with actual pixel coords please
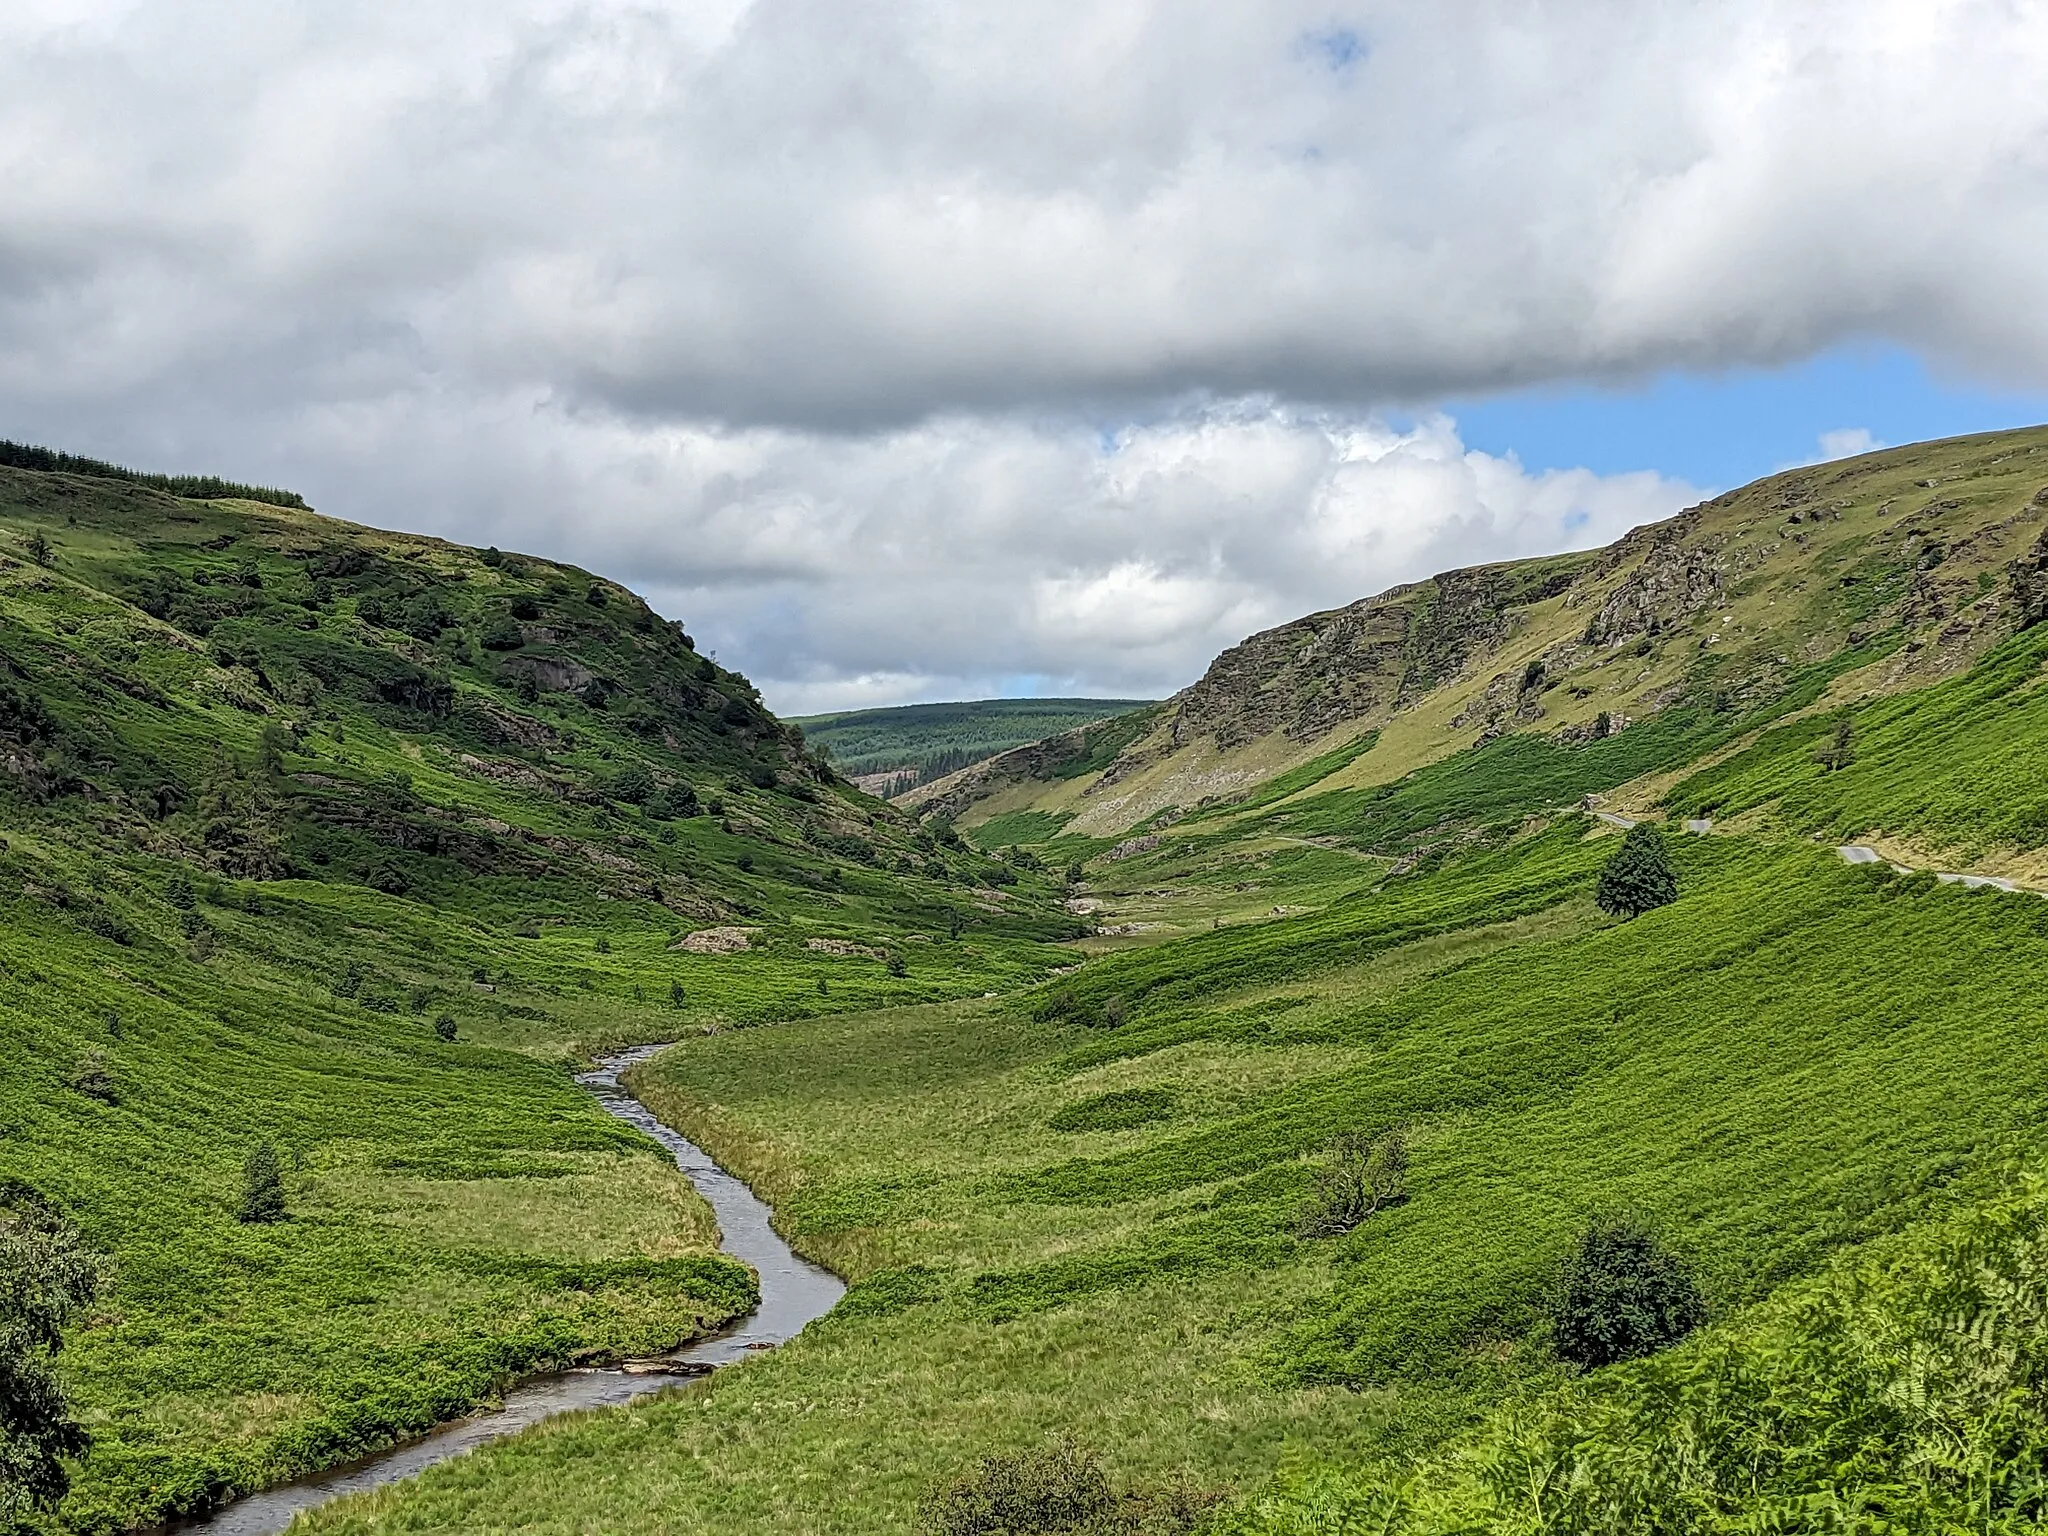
left=0, top=0, right=2048, bottom=713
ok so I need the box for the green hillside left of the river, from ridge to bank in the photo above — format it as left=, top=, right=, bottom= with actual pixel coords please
left=0, top=469, right=1073, bottom=1530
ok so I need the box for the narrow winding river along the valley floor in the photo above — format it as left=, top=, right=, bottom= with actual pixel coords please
left=168, top=1044, right=846, bottom=1536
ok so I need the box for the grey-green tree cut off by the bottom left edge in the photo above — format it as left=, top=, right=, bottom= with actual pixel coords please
left=0, top=1202, right=104, bottom=1530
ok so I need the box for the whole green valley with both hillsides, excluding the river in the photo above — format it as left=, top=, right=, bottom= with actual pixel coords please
left=12, top=428, right=2048, bottom=1536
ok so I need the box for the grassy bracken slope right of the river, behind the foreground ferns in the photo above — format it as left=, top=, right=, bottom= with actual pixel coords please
left=292, top=825, right=2048, bottom=1532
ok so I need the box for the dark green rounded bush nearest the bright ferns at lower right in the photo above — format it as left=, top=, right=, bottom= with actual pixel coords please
left=1550, top=1219, right=1706, bottom=1370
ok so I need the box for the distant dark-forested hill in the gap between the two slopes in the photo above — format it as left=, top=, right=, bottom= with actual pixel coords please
left=795, top=698, right=1151, bottom=797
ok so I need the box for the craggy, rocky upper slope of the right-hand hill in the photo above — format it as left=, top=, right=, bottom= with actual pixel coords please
left=925, top=428, right=2048, bottom=860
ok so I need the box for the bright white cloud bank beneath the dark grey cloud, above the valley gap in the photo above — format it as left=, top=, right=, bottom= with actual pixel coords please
left=247, top=399, right=1702, bottom=713
